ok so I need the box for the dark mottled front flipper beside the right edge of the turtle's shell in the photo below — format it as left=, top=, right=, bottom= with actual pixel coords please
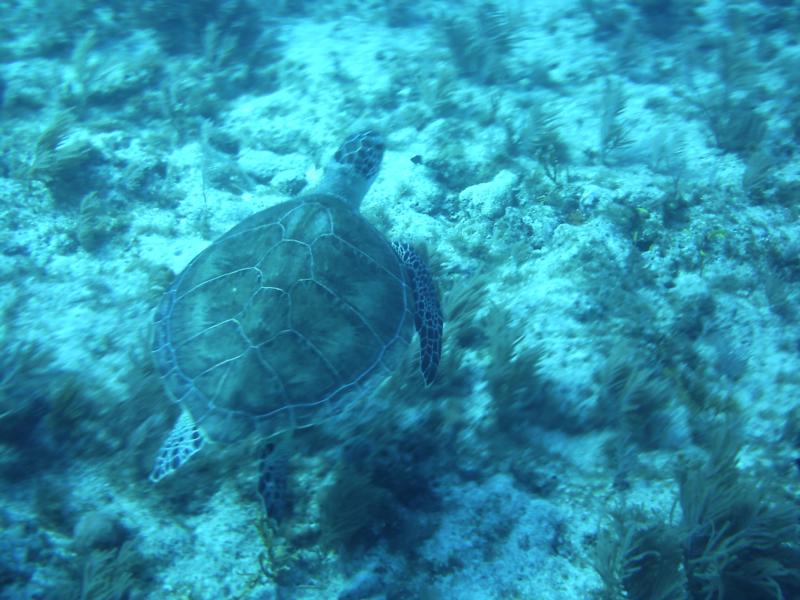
left=392, top=242, right=443, bottom=385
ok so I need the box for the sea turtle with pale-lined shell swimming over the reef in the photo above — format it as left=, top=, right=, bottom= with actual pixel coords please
left=150, top=131, right=442, bottom=482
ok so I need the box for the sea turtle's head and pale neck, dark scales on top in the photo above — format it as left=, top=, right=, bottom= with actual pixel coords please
left=318, top=130, right=386, bottom=210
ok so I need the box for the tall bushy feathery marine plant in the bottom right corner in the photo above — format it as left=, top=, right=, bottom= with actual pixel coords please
left=677, top=424, right=800, bottom=600
